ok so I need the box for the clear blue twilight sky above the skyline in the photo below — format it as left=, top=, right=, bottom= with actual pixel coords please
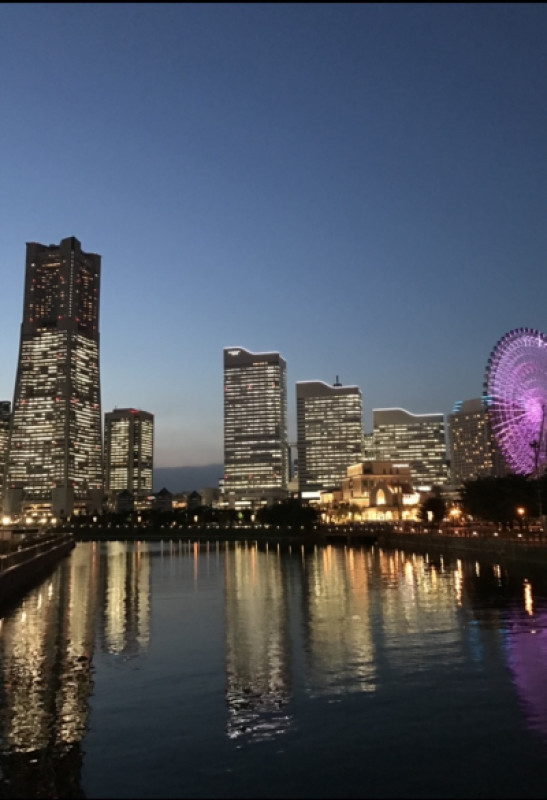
left=0, top=3, right=547, bottom=467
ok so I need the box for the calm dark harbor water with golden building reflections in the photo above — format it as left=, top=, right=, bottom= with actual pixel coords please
left=0, top=540, right=547, bottom=798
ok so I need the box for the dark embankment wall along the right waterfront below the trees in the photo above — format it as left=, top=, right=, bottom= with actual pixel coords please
left=378, top=532, right=547, bottom=568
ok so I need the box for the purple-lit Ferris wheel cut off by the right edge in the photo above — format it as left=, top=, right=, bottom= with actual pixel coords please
left=484, top=328, right=547, bottom=475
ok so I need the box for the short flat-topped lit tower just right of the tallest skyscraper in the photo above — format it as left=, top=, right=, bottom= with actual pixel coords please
left=104, top=408, right=154, bottom=506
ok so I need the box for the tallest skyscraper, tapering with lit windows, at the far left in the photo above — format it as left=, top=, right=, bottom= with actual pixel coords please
left=4, top=236, right=103, bottom=516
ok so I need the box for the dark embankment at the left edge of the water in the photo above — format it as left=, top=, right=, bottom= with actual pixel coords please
left=0, top=533, right=75, bottom=610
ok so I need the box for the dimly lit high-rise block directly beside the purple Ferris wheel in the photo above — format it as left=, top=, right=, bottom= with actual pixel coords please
left=448, top=397, right=506, bottom=486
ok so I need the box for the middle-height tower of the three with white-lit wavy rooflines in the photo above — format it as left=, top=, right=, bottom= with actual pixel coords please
left=296, top=381, right=363, bottom=497
